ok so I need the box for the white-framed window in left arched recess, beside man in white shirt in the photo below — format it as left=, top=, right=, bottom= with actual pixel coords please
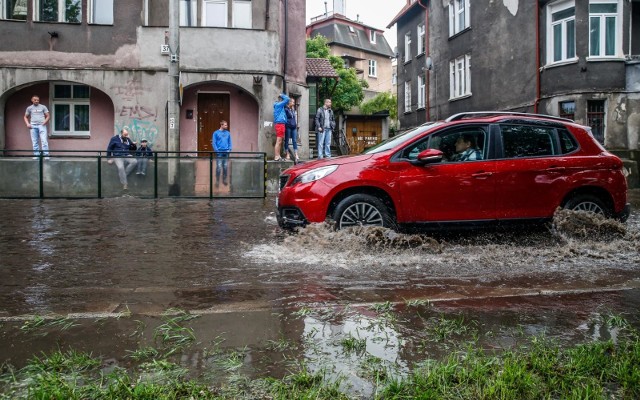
left=52, top=83, right=90, bottom=136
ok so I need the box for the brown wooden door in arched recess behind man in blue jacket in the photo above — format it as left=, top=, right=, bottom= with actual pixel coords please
left=198, top=93, right=231, bottom=151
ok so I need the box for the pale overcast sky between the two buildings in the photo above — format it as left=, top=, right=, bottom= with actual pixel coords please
left=306, top=0, right=407, bottom=49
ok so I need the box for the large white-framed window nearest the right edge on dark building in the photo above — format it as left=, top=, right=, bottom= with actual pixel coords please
left=589, top=0, right=622, bottom=57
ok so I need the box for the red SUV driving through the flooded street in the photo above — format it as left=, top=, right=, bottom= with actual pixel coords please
left=277, top=112, right=630, bottom=230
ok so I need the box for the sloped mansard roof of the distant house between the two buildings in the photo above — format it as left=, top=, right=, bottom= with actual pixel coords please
left=307, top=14, right=394, bottom=57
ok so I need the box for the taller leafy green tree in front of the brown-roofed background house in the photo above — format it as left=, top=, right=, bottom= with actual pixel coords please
left=307, top=35, right=368, bottom=111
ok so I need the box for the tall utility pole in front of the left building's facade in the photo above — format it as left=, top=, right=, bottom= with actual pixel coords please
left=167, top=0, right=180, bottom=196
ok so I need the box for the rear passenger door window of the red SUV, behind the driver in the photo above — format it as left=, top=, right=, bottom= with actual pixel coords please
left=500, top=125, right=558, bottom=158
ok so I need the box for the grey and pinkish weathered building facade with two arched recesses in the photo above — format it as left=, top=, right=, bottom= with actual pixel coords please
left=0, top=0, right=308, bottom=156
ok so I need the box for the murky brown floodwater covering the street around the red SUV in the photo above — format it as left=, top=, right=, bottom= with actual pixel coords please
left=0, top=193, right=640, bottom=397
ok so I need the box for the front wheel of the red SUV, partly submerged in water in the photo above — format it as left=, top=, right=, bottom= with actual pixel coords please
left=333, top=194, right=395, bottom=229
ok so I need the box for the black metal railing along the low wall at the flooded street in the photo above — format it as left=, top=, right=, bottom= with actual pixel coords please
left=0, top=150, right=267, bottom=199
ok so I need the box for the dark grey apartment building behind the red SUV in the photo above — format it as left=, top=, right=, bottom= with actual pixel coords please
left=389, top=0, right=640, bottom=149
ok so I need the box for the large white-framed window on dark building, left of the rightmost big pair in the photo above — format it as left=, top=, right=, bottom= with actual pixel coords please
left=547, top=1, right=576, bottom=63
